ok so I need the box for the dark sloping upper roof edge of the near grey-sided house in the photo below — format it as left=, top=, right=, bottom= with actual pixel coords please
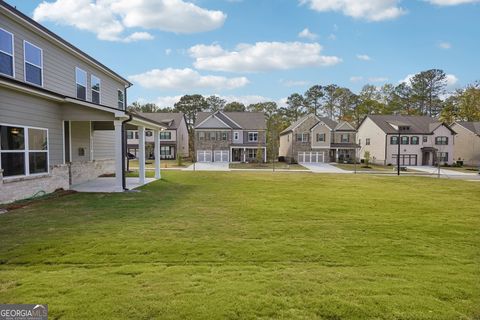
left=0, top=0, right=132, bottom=87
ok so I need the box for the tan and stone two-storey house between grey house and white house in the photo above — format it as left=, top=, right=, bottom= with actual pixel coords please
left=279, top=114, right=358, bottom=162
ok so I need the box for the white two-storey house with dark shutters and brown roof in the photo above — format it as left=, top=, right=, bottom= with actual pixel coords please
left=357, top=115, right=455, bottom=166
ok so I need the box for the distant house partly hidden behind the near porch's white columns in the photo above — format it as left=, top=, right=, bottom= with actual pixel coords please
left=127, top=112, right=189, bottom=160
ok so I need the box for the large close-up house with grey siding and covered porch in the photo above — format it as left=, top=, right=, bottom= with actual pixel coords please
left=0, top=1, right=164, bottom=203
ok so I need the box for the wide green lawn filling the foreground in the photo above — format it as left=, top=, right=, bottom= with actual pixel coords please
left=0, top=171, right=480, bottom=320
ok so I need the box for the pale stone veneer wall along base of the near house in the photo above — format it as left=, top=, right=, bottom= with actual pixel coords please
left=0, top=159, right=115, bottom=203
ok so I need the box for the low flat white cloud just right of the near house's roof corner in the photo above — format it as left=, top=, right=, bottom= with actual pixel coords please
left=129, top=68, right=249, bottom=90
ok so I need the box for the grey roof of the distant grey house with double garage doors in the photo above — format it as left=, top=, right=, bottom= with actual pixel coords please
left=194, top=111, right=267, bottom=130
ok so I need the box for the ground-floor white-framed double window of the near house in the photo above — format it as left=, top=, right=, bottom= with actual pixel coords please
left=0, top=124, right=48, bottom=177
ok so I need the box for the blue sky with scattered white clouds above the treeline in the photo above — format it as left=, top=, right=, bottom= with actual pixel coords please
left=7, top=0, right=480, bottom=106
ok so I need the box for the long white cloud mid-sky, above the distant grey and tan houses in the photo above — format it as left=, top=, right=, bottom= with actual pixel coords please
left=189, top=42, right=342, bottom=72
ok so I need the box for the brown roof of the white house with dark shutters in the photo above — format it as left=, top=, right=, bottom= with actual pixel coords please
left=359, top=115, right=455, bottom=134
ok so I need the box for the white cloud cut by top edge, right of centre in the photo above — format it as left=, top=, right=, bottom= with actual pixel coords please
left=299, top=0, right=404, bottom=21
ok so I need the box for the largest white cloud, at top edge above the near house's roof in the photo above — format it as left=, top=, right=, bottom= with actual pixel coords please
left=33, top=0, right=226, bottom=42
